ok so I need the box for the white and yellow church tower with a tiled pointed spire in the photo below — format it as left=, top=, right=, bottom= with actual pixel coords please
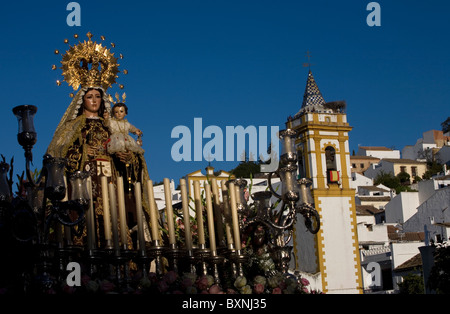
left=286, top=70, right=363, bottom=293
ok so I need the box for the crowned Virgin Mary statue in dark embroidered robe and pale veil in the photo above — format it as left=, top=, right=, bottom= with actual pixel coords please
left=47, top=33, right=150, bottom=249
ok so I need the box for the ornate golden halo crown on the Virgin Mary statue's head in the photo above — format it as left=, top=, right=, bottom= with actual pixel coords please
left=52, top=32, right=128, bottom=94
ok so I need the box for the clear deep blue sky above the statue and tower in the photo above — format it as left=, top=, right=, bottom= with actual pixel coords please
left=0, top=0, right=450, bottom=181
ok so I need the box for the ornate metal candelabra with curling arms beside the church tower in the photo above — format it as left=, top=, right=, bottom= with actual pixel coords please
left=242, top=129, right=320, bottom=274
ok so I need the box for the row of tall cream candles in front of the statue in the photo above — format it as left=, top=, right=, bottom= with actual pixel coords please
left=86, top=176, right=243, bottom=256
